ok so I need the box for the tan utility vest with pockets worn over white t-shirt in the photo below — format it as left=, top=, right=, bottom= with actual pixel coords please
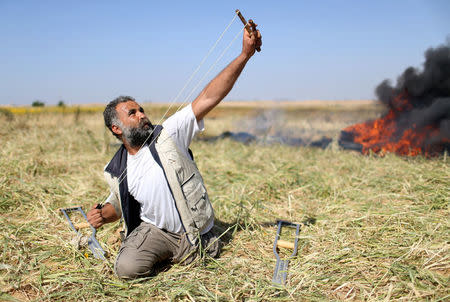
left=105, top=129, right=214, bottom=243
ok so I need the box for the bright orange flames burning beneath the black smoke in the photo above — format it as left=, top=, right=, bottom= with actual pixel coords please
left=339, top=92, right=450, bottom=156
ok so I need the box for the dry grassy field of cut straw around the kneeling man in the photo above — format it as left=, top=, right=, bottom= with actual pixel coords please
left=0, top=102, right=450, bottom=301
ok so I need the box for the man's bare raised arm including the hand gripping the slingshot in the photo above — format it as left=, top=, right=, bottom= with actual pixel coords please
left=192, top=26, right=262, bottom=121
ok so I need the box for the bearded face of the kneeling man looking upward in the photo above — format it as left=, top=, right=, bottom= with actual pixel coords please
left=116, top=101, right=153, bottom=147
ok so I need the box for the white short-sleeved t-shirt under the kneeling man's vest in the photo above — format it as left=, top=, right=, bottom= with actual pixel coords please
left=127, top=105, right=212, bottom=233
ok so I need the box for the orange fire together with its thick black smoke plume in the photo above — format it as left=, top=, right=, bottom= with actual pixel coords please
left=339, top=43, right=450, bottom=156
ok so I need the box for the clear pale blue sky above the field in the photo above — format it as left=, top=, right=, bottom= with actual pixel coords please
left=0, top=0, right=450, bottom=105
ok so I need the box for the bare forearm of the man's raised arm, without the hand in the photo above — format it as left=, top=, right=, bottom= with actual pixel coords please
left=192, top=53, right=250, bottom=121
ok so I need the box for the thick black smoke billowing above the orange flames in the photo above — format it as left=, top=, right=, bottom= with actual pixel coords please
left=375, top=39, right=450, bottom=149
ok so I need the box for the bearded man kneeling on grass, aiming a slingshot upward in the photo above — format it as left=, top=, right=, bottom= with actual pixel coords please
left=87, top=28, right=262, bottom=279
